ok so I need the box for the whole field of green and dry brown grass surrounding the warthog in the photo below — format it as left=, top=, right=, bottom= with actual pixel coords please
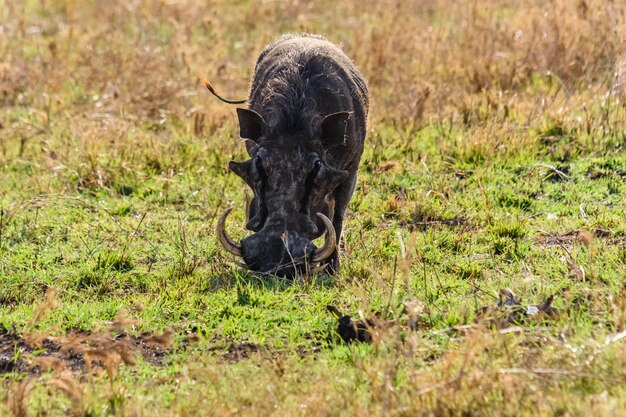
left=0, top=0, right=626, bottom=417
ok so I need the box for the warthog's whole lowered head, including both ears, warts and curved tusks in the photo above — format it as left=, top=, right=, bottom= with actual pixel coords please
left=217, top=109, right=349, bottom=276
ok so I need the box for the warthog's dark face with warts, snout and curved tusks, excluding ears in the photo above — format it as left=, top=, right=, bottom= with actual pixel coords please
left=218, top=139, right=348, bottom=276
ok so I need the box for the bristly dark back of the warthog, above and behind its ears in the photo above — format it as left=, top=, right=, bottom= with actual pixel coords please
left=248, top=34, right=369, bottom=138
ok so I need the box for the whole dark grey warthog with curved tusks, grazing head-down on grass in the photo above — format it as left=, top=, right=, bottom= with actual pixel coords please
left=211, top=35, right=369, bottom=277
